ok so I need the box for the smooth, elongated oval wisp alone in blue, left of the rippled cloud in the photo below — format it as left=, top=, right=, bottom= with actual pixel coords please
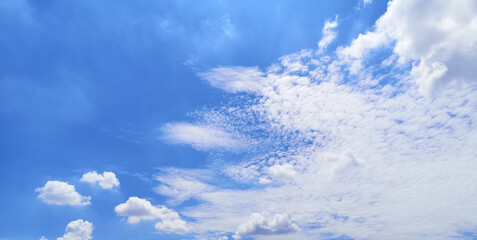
left=162, top=123, right=246, bottom=150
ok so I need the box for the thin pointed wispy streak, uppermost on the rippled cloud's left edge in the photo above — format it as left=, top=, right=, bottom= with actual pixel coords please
left=198, top=67, right=264, bottom=93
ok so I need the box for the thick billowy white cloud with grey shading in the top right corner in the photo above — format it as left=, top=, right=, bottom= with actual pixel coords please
left=340, top=0, right=477, bottom=93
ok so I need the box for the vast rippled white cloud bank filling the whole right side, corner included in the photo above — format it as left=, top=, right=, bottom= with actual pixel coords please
left=156, top=0, right=477, bottom=239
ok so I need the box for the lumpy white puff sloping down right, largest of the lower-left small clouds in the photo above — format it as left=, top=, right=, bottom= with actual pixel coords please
left=114, top=197, right=190, bottom=234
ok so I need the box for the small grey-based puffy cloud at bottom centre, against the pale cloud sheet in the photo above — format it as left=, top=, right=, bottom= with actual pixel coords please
left=234, top=213, right=300, bottom=238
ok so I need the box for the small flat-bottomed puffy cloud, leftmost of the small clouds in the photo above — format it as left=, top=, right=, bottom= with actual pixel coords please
left=35, top=181, right=91, bottom=205
